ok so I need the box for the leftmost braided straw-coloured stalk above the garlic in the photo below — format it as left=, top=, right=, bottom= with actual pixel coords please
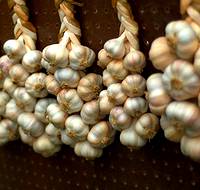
left=8, top=0, right=37, bottom=50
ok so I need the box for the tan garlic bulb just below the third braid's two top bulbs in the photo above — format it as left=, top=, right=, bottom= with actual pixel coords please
left=106, top=60, right=128, bottom=80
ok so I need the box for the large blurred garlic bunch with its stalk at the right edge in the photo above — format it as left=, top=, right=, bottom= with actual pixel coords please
left=147, top=0, right=200, bottom=160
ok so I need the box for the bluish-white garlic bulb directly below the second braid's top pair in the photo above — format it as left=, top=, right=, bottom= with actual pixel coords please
left=54, top=67, right=80, bottom=88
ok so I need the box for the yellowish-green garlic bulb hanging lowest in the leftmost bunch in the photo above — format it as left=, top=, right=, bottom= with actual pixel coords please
left=33, top=134, right=61, bottom=157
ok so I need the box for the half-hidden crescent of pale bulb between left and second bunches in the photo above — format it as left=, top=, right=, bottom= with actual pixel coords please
left=34, top=98, right=56, bottom=123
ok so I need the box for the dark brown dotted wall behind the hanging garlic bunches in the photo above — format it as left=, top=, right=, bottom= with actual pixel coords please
left=0, top=0, right=200, bottom=190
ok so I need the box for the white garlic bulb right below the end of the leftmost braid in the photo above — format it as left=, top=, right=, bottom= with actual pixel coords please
left=22, top=50, right=42, bottom=73
